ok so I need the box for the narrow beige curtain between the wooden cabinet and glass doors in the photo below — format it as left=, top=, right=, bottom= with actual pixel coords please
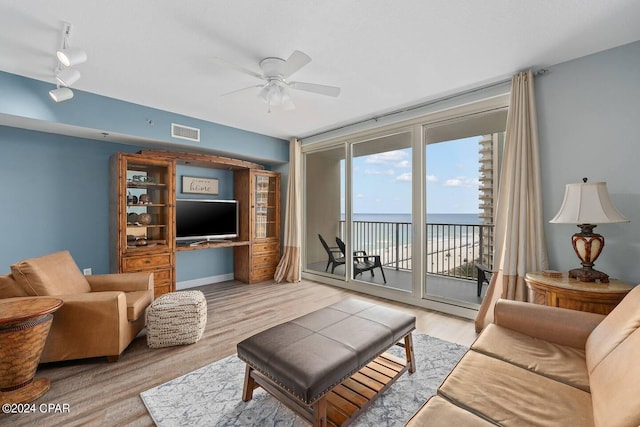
left=274, top=138, right=302, bottom=283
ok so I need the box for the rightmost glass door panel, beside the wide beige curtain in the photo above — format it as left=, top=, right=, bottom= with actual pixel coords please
left=424, top=110, right=506, bottom=307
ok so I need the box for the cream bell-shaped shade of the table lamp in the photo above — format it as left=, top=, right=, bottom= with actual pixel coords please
left=549, top=182, right=629, bottom=224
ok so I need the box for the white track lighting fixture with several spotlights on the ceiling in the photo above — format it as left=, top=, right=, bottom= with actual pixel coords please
left=49, top=22, right=87, bottom=102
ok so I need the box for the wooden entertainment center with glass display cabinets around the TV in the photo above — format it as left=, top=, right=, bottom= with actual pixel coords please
left=110, top=150, right=280, bottom=296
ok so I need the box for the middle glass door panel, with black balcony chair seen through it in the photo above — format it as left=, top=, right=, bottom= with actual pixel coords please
left=345, top=132, right=413, bottom=292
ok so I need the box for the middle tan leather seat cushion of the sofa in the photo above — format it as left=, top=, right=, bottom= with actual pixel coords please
left=438, top=350, right=593, bottom=426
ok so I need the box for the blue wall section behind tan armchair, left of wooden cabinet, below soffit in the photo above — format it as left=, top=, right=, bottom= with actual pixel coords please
left=0, top=126, right=135, bottom=274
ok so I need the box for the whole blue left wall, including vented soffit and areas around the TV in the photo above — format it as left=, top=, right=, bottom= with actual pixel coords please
left=0, top=72, right=289, bottom=282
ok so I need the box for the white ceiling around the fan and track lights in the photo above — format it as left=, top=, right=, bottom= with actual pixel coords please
left=0, top=0, right=640, bottom=139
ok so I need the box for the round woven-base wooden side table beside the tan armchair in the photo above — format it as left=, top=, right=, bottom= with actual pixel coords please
left=0, top=297, right=62, bottom=404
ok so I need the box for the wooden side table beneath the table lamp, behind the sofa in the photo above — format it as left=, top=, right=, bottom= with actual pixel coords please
left=525, top=272, right=632, bottom=314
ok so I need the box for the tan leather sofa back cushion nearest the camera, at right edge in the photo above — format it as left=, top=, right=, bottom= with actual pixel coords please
left=590, top=328, right=640, bottom=427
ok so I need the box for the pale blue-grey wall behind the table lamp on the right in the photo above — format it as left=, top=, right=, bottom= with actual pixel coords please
left=536, top=42, right=640, bottom=284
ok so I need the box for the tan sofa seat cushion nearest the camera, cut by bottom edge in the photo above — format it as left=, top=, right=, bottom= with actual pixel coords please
left=405, top=396, right=497, bottom=427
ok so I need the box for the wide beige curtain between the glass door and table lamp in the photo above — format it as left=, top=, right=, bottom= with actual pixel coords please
left=476, top=71, right=548, bottom=332
